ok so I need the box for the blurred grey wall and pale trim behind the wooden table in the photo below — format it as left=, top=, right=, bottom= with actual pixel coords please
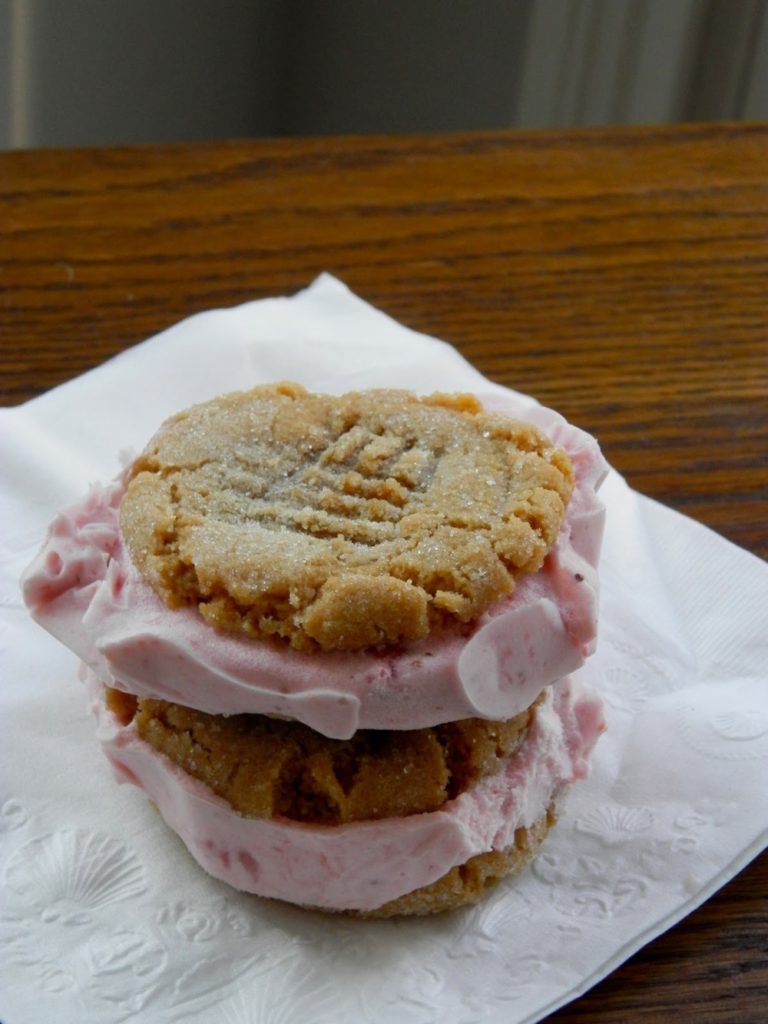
left=0, top=0, right=768, bottom=147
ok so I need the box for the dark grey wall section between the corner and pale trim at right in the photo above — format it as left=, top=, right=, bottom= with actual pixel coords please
left=278, top=0, right=537, bottom=134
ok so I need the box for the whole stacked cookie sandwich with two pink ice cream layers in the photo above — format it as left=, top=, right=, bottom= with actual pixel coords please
left=24, top=384, right=605, bottom=916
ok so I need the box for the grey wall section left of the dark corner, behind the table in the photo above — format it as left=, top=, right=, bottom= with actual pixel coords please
left=0, top=0, right=280, bottom=146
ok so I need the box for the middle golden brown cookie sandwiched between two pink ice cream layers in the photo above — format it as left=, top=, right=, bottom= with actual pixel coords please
left=106, top=688, right=531, bottom=825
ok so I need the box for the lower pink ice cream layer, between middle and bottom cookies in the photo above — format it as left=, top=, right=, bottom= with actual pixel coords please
left=87, top=672, right=604, bottom=910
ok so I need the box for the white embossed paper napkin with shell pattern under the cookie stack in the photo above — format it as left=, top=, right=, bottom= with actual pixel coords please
left=0, top=275, right=768, bottom=1024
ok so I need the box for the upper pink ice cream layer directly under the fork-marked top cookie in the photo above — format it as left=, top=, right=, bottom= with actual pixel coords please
left=24, top=395, right=606, bottom=738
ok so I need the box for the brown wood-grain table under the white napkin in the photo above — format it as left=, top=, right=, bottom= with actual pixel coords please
left=0, top=125, right=768, bottom=1024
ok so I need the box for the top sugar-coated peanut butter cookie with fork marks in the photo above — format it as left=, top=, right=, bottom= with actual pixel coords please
left=120, top=384, right=572, bottom=650
